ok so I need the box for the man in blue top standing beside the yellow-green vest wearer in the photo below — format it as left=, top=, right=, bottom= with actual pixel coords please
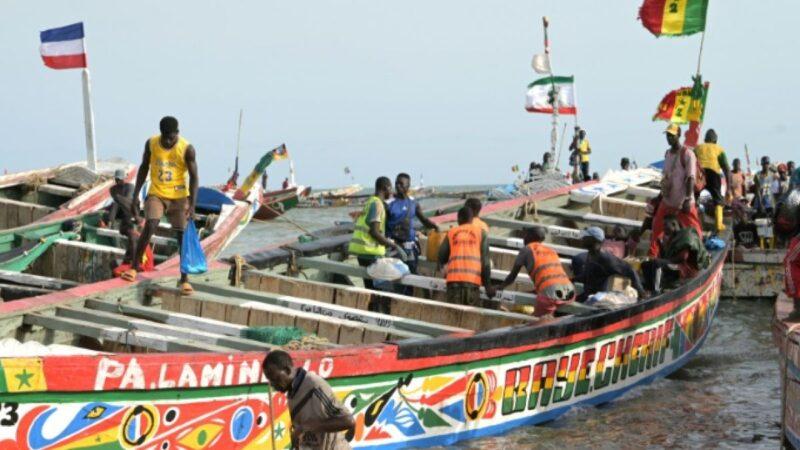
left=386, top=173, right=439, bottom=284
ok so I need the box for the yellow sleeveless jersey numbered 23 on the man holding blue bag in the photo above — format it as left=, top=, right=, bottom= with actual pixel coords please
left=147, top=135, right=189, bottom=200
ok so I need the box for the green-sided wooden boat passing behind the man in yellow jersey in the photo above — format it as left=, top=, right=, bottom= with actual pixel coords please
left=0, top=187, right=257, bottom=301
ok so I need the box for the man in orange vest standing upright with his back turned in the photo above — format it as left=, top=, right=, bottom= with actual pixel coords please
left=439, top=206, right=495, bottom=306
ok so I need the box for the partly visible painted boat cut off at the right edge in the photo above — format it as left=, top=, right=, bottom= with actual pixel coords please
left=772, top=293, right=800, bottom=449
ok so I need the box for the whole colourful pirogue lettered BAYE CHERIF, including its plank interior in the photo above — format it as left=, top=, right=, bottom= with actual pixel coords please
left=0, top=168, right=725, bottom=449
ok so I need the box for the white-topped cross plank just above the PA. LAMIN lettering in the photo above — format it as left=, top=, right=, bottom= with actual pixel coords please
left=23, top=313, right=231, bottom=353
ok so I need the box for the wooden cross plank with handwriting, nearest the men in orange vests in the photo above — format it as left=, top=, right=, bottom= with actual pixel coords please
left=244, top=270, right=536, bottom=330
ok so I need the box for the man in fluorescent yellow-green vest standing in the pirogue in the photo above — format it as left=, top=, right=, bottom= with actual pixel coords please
left=347, top=177, right=406, bottom=314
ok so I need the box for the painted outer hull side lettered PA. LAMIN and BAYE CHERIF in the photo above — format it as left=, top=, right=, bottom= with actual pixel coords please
left=0, top=251, right=723, bottom=449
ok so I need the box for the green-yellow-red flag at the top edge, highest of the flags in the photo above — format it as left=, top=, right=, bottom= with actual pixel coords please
left=639, top=0, right=708, bottom=37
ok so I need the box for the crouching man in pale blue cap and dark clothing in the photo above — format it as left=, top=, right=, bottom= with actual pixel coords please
left=575, top=227, right=644, bottom=302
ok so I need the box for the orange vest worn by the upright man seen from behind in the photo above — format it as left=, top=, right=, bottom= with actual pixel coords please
left=446, top=224, right=482, bottom=286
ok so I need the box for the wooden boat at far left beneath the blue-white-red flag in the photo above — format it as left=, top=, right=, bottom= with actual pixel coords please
left=0, top=160, right=136, bottom=230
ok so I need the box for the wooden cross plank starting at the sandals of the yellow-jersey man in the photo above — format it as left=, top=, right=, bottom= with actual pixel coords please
left=148, top=284, right=427, bottom=346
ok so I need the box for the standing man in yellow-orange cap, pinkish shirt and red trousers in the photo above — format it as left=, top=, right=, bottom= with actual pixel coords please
left=649, top=124, right=703, bottom=257
